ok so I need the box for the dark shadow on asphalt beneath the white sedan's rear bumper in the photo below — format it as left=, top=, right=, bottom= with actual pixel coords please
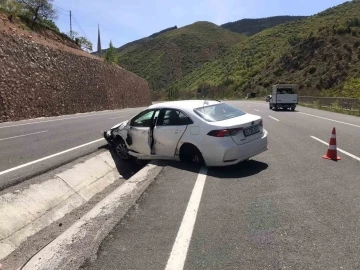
left=208, top=160, right=269, bottom=179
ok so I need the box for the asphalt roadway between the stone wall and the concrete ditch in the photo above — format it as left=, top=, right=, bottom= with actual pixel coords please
left=0, top=108, right=142, bottom=190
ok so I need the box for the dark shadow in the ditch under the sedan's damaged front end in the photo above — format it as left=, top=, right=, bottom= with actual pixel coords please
left=99, top=145, right=148, bottom=180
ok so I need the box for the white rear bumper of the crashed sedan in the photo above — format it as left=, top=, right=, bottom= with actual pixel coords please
left=203, top=130, right=268, bottom=166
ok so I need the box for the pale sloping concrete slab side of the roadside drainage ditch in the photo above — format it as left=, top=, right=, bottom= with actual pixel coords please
left=0, top=152, right=121, bottom=259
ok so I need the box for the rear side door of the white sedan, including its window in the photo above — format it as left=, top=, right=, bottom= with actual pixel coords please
left=154, top=109, right=192, bottom=157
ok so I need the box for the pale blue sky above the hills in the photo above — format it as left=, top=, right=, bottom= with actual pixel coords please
left=53, top=0, right=345, bottom=50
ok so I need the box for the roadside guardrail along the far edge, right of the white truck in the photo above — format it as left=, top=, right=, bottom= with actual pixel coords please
left=299, top=96, right=360, bottom=115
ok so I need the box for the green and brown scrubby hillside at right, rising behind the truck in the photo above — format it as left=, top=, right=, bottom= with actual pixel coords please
left=171, top=0, right=360, bottom=99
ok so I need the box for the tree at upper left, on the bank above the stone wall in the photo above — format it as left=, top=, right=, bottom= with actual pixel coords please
left=18, top=0, right=57, bottom=24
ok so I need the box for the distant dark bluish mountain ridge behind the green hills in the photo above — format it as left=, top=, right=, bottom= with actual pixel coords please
left=221, top=16, right=307, bottom=36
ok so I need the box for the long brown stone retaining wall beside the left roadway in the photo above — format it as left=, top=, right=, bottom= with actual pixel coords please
left=0, top=31, right=151, bottom=122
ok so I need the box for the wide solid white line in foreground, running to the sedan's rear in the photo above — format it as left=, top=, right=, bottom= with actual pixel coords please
left=165, top=167, right=207, bottom=270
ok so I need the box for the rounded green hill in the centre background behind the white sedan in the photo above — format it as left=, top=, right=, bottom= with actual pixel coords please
left=118, top=22, right=245, bottom=90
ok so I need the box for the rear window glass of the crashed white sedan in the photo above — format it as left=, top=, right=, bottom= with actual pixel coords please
left=194, top=103, right=246, bottom=122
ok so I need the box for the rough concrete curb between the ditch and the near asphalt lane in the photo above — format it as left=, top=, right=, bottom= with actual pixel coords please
left=18, top=162, right=163, bottom=270
